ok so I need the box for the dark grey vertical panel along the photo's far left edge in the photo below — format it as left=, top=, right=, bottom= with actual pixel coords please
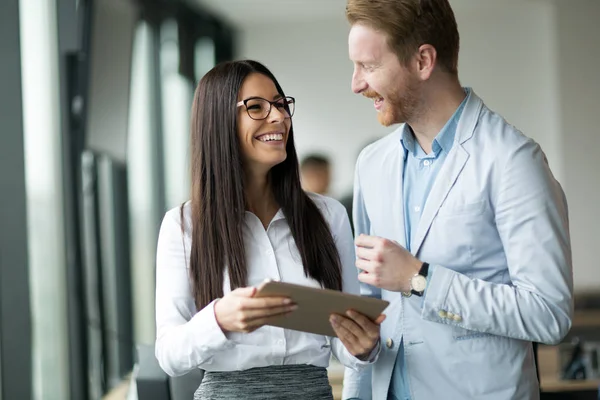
left=0, top=0, right=33, bottom=400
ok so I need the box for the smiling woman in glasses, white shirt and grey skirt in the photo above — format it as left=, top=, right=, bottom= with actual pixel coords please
left=156, top=61, right=384, bottom=399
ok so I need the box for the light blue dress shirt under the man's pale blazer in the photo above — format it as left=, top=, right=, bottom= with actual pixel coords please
left=388, top=89, right=469, bottom=400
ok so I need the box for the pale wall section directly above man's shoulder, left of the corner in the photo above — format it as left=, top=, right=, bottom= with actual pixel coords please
left=455, top=1, right=562, bottom=180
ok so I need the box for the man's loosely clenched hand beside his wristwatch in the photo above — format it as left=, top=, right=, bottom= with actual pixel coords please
left=356, top=235, right=423, bottom=292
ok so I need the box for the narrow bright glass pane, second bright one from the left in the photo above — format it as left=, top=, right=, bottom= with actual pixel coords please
left=127, top=23, right=161, bottom=344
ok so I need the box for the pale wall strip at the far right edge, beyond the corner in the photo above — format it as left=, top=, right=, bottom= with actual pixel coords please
left=557, top=0, right=600, bottom=290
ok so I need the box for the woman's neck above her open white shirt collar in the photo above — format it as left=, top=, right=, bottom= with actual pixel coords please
left=245, top=169, right=279, bottom=229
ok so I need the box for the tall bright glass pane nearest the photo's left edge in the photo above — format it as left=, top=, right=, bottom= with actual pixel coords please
left=19, top=0, right=69, bottom=400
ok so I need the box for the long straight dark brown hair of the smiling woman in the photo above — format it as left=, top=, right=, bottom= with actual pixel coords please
left=181, top=60, right=342, bottom=309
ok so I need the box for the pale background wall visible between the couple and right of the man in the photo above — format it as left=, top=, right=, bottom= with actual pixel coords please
left=238, top=0, right=600, bottom=290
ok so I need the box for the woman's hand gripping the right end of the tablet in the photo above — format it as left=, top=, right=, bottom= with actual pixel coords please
left=329, top=310, right=385, bottom=359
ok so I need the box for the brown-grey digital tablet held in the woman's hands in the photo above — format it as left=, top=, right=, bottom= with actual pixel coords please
left=255, top=281, right=389, bottom=337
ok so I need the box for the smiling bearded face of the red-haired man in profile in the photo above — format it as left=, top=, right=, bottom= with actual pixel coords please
left=348, top=24, right=421, bottom=126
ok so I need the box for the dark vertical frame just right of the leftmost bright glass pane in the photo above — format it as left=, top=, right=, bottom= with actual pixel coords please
left=57, top=0, right=90, bottom=399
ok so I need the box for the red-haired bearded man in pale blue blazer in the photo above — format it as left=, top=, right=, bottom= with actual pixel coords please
left=343, top=0, right=572, bottom=400
